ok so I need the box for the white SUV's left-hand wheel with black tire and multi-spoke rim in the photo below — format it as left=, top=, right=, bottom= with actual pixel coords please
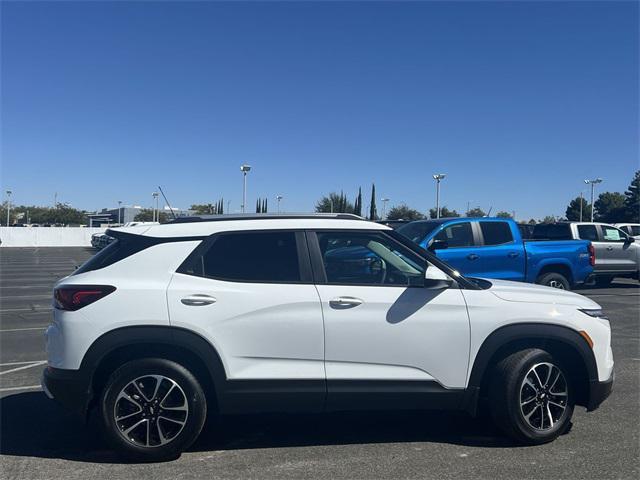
left=100, top=358, right=207, bottom=462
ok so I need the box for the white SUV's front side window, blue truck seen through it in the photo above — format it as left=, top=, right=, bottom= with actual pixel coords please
left=317, top=232, right=425, bottom=286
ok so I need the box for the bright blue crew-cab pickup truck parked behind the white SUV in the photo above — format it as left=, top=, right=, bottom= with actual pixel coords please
left=397, top=217, right=595, bottom=290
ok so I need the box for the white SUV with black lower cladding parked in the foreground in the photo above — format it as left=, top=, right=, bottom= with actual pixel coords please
left=43, top=215, right=613, bottom=460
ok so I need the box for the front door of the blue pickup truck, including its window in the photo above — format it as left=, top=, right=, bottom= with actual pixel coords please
left=432, top=221, right=483, bottom=277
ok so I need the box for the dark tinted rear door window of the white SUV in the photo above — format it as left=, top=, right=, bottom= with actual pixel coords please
left=178, top=231, right=301, bottom=283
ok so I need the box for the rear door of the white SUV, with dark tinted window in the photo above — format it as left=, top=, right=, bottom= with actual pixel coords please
left=167, top=230, right=326, bottom=410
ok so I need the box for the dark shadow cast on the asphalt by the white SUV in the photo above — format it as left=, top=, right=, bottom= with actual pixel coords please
left=0, top=392, right=513, bottom=463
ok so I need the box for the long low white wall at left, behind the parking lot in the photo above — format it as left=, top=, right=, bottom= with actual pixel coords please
left=0, top=227, right=105, bottom=248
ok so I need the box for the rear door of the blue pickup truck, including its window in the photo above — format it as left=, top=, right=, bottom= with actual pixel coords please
left=478, top=220, right=526, bottom=282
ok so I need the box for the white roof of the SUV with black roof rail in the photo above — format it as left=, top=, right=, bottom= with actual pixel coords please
left=109, top=214, right=391, bottom=238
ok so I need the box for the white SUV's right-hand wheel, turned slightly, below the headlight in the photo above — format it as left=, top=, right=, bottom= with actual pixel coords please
left=489, top=348, right=575, bottom=445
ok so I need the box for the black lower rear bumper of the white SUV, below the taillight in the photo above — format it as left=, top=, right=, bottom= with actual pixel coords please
left=41, top=367, right=92, bottom=419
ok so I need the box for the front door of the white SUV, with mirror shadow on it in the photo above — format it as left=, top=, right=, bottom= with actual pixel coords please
left=309, top=231, right=469, bottom=409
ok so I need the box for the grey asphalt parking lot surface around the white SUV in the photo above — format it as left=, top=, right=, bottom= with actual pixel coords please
left=0, top=248, right=640, bottom=480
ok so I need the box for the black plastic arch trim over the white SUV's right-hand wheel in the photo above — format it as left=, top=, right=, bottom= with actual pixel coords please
left=465, top=323, right=598, bottom=415
